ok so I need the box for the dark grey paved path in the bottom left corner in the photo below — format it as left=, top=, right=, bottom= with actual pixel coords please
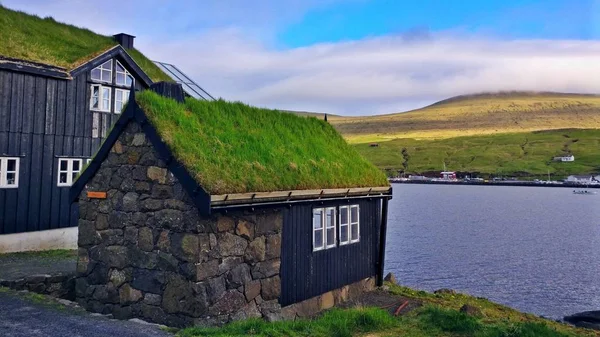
left=0, top=288, right=172, bottom=337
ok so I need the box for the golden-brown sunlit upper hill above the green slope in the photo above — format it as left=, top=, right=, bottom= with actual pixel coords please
left=329, top=92, right=600, bottom=143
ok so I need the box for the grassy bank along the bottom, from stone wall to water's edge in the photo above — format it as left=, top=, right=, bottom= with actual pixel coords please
left=178, top=286, right=600, bottom=337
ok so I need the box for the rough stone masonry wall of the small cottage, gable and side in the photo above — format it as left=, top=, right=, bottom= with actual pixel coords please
left=75, top=123, right=283, bottom=326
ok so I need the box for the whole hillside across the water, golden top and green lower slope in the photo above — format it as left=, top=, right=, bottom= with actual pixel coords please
left=329, top=92, right=600, bottom=177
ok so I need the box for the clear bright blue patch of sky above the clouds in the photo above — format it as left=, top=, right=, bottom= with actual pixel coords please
left=277, top=0, right=600, bottom=47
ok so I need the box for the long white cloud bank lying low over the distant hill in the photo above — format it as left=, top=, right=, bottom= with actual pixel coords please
left=143, top=31, right=600, bottom=114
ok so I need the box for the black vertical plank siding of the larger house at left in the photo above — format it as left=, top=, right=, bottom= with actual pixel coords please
left=0, top=51, right=150, bottom=234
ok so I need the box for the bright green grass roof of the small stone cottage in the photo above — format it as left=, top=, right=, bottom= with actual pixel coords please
left=136, top=90, right=388, bottom=195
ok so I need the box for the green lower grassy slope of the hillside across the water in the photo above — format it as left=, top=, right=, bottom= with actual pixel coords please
left=354, top=129, right=600, bottom=177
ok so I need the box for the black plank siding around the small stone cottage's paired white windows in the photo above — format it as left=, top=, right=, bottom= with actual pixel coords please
left=280, top=199, right=381, bottom=306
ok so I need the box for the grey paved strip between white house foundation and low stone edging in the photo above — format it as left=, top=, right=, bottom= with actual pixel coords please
left=0, top=251, right=77, bottom=281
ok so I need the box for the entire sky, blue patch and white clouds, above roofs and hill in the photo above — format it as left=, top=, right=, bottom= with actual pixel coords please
left=0, top=0, right=600, bottom=115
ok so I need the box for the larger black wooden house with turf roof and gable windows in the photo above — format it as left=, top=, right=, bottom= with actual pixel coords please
left=0, top=6, right=176, bottom=234
